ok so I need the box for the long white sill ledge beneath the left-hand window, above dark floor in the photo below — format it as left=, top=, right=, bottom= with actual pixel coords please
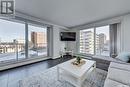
left=0, top=57, right=51, bottom=71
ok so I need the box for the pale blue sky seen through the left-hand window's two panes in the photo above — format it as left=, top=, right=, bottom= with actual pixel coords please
left=0, top=19, right=46, bottom=42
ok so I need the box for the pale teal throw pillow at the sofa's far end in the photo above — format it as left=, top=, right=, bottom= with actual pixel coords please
left=116, top=52, right=130, bottom=62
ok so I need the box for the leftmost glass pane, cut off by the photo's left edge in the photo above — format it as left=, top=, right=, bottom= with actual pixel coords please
left=0, top=19, right=25, bottom=62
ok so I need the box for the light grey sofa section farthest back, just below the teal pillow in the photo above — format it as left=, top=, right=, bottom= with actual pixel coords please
left=109, top=62, right=130, bottom=71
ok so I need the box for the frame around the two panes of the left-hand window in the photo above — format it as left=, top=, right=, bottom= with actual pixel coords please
left=0, top=18, right=50, bottom=64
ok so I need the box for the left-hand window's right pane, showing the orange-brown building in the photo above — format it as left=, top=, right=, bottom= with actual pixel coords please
left=28, top=25, right=47, bottom=57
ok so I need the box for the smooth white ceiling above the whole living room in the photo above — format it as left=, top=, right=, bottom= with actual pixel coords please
left=15, top=0, right=130, bottom=27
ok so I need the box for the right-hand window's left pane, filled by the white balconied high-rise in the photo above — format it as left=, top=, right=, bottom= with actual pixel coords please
left=80, top=28, right=94, bottom=54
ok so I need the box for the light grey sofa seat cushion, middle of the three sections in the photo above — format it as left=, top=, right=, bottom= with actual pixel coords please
left=107, top=68, right=130, bottom=85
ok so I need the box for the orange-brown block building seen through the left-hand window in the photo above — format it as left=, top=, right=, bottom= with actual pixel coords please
left=31, top=32, right=47, bottom=48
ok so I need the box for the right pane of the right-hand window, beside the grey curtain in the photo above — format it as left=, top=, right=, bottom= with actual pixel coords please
left=96, top=25, right=110, bottom=56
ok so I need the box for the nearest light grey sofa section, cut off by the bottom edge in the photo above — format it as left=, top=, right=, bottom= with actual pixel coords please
left=104, top=79, right=129, bottom=87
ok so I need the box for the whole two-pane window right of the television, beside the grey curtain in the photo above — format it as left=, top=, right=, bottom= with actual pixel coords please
left=80, top=25, right=110, bottom=56
